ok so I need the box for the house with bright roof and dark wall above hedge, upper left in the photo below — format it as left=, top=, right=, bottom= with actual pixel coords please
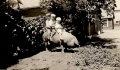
left=20, top=0, right=45, bottom=17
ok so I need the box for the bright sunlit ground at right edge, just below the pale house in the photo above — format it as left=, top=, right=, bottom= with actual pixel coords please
left=98, top=26, right=120, bottom=49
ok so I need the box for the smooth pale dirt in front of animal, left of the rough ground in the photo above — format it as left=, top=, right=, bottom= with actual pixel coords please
left=8, top=51, right=79, bottom=70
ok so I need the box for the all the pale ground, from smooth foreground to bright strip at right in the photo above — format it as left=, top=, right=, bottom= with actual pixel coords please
left=7, top=27, right=120, bottom=70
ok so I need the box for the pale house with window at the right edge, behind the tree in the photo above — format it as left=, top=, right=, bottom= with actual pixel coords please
left=101, top=0, right=120, bottom=29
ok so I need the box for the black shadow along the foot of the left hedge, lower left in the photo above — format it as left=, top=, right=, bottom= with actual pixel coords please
left=0, top=45, right=45, bottom=69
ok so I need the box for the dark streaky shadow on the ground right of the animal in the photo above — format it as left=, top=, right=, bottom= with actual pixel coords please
left=81, top=36, right=117, bottom=49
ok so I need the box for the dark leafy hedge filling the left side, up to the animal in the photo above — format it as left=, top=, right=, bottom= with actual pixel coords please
left=0, top=4, right=45, bottom=69
